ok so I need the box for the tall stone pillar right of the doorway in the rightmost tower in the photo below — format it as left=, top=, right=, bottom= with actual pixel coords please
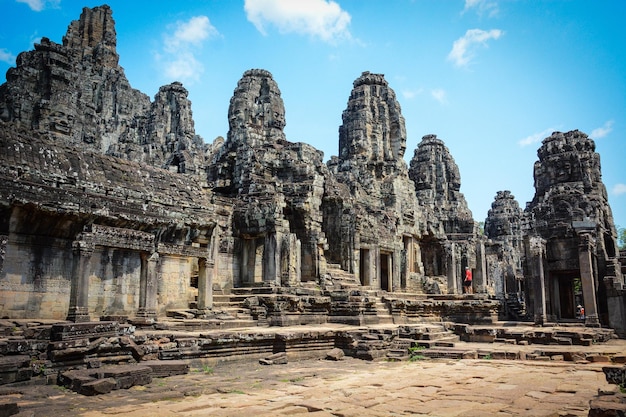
left=578, top=231, right=600, bottom=327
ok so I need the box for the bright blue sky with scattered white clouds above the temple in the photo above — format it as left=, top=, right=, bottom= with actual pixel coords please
left=0, top=0, right=626, bottom=231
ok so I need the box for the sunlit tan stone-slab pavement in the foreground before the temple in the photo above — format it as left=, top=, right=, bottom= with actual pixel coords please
left=4, top=340, right=626, bottom=417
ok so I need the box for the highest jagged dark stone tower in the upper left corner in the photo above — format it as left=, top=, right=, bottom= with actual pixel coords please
left=0, top=6, right=150, bottom=153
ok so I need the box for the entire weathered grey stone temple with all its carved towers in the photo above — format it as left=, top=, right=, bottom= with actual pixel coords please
left=0, top=6, right=626, bottom=385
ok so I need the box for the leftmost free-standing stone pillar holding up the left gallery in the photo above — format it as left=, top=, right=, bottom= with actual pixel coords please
left=67, top=240, right=95, bottom=323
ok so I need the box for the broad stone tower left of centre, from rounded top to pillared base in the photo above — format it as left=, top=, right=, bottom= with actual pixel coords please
left=208, top=69, right=329, bottom=285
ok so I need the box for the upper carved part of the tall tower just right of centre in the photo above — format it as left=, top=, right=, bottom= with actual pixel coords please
left=329, top=72, right=414, bottom=214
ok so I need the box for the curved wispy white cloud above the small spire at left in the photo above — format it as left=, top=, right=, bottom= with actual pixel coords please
left=156, top=16, right=220, bottom=84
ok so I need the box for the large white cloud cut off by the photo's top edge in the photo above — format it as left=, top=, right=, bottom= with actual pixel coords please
left=244, top=0, right=351, bottom=43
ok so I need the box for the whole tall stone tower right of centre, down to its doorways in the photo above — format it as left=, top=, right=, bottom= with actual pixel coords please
left=324, top=72, right=423, bottom=291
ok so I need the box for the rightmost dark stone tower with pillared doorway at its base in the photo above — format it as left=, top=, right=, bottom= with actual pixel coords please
left=525, top=130, right=625, bottom=328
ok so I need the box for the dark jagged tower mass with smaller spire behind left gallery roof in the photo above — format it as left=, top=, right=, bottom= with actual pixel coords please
left=0, top=5, right=204, bottom=173
